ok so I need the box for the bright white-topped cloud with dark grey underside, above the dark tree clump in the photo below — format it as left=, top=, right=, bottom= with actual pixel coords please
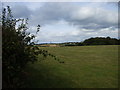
left=71, top=8, right=118, bottom=29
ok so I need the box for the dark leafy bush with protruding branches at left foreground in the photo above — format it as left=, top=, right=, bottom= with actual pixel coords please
left=2, top=6, right=60, bottom=88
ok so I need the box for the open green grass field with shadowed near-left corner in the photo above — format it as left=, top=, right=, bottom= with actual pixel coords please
left=26, top=45, right=118, bottom=88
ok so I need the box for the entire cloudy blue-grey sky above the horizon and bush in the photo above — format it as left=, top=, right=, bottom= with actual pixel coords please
left=0, top=0, right=118, bottom=43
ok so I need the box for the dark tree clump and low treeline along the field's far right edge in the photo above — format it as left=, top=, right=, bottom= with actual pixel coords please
left=63, top=37, right=120, bottom=46
